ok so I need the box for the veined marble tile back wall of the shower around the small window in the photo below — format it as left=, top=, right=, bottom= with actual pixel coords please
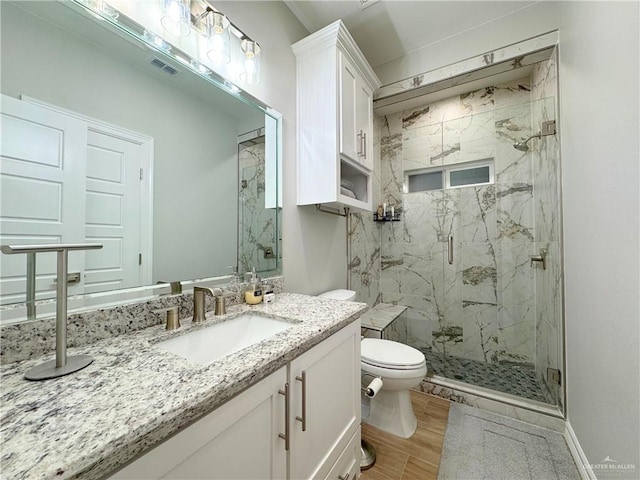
left=350, top=74, right=560, bottom=386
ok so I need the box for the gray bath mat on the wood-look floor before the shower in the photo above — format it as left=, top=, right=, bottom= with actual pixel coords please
left=438, top=403, right=580, bottom=480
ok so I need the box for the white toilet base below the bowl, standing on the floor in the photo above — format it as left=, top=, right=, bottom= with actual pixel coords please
left=362, top=388, right=418, bottom=438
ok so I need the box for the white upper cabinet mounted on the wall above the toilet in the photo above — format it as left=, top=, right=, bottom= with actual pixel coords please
left=292, top=20, right=380, bottom=211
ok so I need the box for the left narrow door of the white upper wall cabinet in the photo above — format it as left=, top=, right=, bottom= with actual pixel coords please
left=338, top=52, right=360, bottom=161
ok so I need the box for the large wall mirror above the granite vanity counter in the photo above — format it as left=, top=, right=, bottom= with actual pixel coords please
left=0, top=1, right=281, bottom=323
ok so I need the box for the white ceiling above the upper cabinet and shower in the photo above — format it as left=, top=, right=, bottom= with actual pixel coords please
left=285, top=0, right=536, bottom=68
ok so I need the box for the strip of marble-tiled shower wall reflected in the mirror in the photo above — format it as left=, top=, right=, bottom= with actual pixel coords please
left=238, top=137, right=277, bottom=272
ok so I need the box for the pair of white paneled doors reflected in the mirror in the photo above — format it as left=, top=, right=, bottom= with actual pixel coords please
left=0, top=95, right=152, bottom=303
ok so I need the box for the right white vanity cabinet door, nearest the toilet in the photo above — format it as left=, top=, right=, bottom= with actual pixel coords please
left=289, top=322, right=360, bottom=480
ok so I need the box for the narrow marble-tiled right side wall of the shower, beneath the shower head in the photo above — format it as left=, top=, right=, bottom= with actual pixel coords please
left=531, top=49, right=563, bottom=403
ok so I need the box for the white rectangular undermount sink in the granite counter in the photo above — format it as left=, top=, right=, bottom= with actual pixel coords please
left=156, top=313, right=294, bottom=365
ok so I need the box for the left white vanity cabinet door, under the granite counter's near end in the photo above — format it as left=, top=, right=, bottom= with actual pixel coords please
left=110, top=367, right=287, bottom=479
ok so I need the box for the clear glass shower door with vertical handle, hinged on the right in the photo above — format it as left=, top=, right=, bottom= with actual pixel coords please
left=433, top=100, right=561, bottom=404
